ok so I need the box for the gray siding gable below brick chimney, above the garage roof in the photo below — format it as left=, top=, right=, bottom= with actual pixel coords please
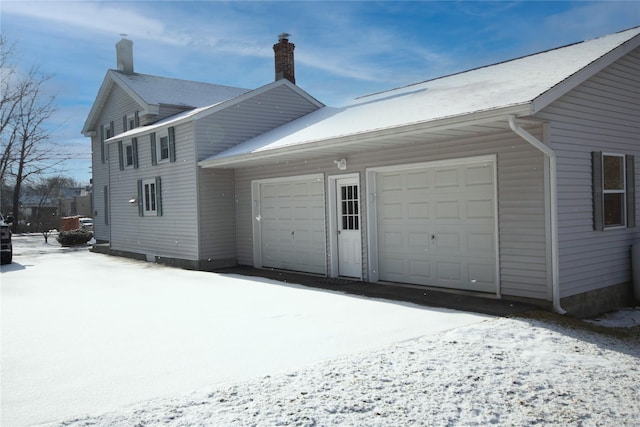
left=196, top=86, right=318, bottom=160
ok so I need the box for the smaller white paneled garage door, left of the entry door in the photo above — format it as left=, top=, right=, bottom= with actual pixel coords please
left=259, top=176, right=327, bottom=274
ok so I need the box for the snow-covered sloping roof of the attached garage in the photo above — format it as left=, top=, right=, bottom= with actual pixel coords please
left=204, top=27, right=640, bottom=164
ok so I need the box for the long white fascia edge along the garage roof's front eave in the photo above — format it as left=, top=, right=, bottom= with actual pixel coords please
left=198, top=102, right=531, bottom=168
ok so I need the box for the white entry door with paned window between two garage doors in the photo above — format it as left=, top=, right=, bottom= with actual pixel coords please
left=336, top=178, right=362, bottom=278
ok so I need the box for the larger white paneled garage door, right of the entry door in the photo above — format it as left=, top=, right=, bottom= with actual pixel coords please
left=376, top=161, right=497, bottom=292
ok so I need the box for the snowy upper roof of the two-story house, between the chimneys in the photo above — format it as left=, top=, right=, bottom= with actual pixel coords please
left=113, top=71, right=249, bottom=107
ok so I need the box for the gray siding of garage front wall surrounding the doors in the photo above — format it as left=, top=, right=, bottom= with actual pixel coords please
left=235, top=127, right=550, bottom=300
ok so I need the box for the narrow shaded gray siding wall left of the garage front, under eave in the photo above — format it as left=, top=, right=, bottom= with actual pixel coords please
left=198, top=169, right=236, bottom=267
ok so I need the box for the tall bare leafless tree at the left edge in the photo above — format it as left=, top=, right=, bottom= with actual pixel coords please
left=0, top=36, right=64, bottom=231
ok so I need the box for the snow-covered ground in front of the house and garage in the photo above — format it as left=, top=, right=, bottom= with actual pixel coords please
left=0, top=235, right=640, bottom=426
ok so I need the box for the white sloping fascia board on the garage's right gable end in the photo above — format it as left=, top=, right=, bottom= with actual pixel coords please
left=531, top=35, right=640, bottom=114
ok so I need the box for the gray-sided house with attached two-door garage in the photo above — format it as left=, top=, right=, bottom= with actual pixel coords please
left=85, top=28, right=640, bottom=316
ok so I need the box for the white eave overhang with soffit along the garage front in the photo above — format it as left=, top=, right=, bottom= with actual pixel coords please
left=198, top=103, right=531, bottom=169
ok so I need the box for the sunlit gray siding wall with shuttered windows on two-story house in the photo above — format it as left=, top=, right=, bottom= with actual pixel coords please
left=109, top=123, right=198, bottom=260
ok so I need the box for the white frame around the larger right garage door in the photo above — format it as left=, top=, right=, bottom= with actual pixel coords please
left=361, top=154, right=501, bottom=298
